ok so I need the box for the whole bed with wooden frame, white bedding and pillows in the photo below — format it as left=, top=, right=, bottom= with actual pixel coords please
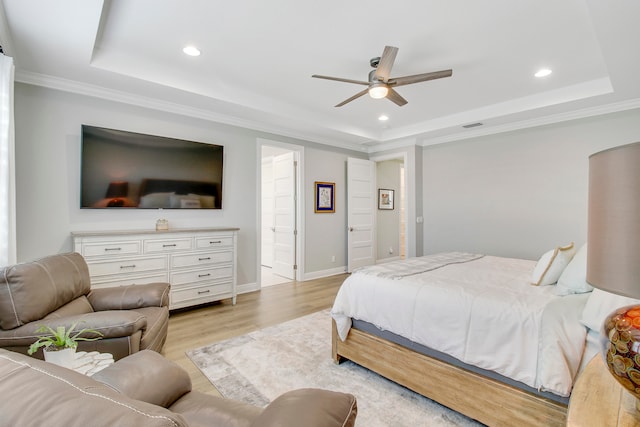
left=331, top=249, right=597, bottom=426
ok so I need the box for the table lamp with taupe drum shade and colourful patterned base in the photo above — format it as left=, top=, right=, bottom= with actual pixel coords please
left=587, top=142, right=640, bottom=408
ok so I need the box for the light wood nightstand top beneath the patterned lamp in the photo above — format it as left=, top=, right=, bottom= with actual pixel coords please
left=567, top=354, right=640, bottom=427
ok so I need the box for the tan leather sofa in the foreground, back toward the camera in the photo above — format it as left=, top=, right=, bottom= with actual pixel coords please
left=0, top=349, right=357, bottom=427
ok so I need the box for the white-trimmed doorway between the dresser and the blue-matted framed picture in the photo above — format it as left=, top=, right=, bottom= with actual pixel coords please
left=257, top=140, right=303, bottom=287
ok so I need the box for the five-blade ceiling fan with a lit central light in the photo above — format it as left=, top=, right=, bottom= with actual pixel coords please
left=311, top=46, right=453, bottom=107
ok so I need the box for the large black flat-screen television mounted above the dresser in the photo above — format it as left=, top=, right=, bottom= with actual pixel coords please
left=80, top=125, right=223, bottom=209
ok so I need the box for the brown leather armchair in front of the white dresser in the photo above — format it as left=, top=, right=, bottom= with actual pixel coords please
left=0, top=253, right=170, bottom=360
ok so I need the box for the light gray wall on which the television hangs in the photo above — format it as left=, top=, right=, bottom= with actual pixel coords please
left=15, top=83, right=358, bottom=285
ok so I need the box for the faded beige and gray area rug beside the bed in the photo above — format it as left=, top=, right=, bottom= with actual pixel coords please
left=187, top=310, right=482, bottom=427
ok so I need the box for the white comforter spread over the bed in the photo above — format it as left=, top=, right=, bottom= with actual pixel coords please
left=331, top=253, right=588, bottom=396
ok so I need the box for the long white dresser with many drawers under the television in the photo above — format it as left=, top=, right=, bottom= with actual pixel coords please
left=71, top=227, right=238, bottom=309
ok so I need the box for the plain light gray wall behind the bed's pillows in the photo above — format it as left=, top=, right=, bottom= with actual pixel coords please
left=423, top=110, right=640, bottom=259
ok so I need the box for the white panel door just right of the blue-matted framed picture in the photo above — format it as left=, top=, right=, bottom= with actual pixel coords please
left=347, top=157, right=376, bottom=272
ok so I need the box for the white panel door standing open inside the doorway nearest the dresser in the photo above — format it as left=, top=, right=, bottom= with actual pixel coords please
left=273, top=152, right=296, bottom=280
